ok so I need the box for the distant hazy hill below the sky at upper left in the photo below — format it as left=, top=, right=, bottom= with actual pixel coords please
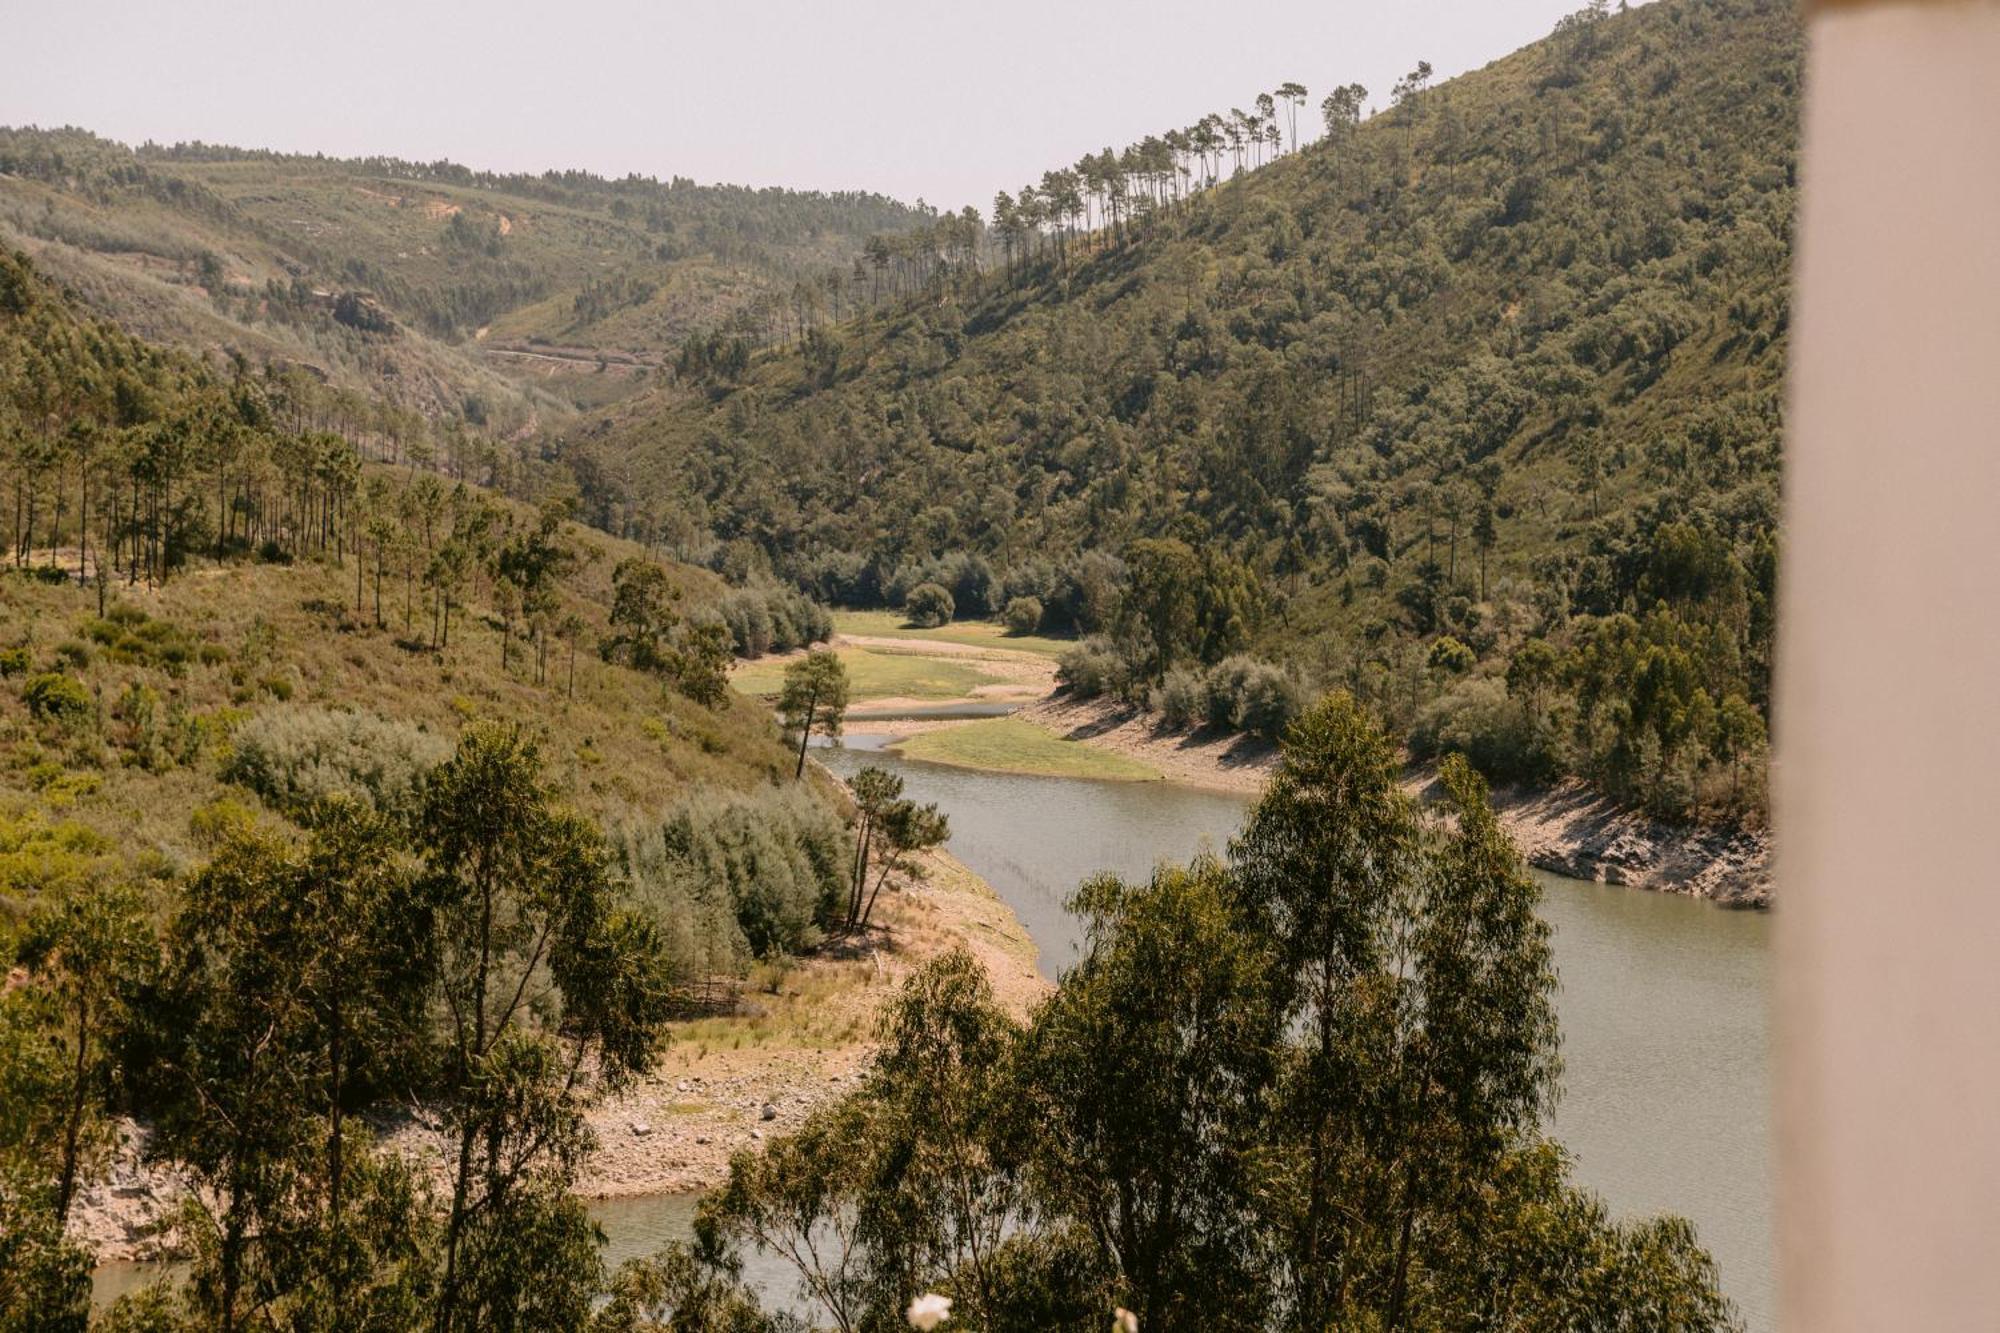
left=0, top=128, right=922, bottom=430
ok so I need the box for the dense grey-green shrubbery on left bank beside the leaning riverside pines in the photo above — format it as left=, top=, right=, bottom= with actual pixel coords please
left=612, top=789, right=852, bottom=983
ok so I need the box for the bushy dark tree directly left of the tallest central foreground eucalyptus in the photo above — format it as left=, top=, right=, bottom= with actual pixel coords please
left=1016, top=857, right=1276, bottom=1329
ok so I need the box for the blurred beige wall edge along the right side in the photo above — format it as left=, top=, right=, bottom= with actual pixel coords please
left=1776, top=4, right=2000, bottom=1333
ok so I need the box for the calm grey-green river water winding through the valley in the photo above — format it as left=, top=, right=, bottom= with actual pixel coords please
left=98, top=735, right=1776, bottom=1333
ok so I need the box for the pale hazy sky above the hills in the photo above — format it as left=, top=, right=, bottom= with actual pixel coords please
left=0, top=0, right=1608, bottom=212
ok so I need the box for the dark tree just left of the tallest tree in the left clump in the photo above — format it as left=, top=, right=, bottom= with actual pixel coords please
left=138, top=807, right=432, bottom=1329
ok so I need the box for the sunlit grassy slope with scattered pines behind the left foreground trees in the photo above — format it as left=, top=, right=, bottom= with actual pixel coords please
left=0, top=236, right=826, bottom=939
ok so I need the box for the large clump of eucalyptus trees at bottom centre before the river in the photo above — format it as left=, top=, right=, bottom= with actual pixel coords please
left=656, top=695, right=1738, bottom=1333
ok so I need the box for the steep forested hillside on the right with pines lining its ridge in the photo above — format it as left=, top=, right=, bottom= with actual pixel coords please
left=560, top=0, right=1802, bottom=819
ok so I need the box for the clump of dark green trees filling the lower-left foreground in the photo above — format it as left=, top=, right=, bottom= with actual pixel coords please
left=0, top=725, right=688, bottom=1329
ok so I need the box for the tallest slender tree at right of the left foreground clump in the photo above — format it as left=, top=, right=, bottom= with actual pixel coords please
left=418, top=725, right=670, bottom=1331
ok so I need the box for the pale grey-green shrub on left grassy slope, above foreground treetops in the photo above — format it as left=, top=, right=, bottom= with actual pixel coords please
left=222, top=709, right=452, bottom=819
